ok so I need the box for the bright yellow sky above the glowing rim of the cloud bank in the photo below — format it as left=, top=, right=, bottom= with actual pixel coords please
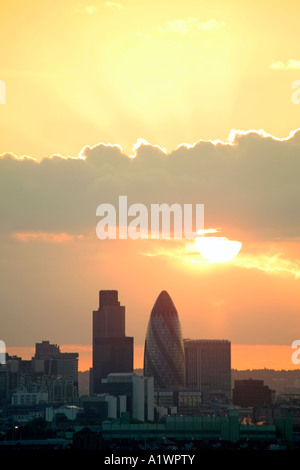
left=0, top=0, right=300, bottom=159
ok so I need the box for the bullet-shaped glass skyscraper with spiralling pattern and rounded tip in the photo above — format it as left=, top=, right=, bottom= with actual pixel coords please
left=144, top=291, right=185, bottom=390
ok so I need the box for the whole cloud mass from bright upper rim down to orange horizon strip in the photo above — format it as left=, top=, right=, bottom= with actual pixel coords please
left=0, top=129, right=300, bottom=345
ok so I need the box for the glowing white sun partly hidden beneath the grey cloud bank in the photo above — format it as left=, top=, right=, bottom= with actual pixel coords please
left=195, top=236, right=242, bottom=263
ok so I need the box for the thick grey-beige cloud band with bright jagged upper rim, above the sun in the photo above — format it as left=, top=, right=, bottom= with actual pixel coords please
left=0, top=130, right=300, bottom=241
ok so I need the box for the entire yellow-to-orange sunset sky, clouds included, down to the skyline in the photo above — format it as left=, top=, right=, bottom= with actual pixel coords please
left=0, top=0, right=300, bottom=370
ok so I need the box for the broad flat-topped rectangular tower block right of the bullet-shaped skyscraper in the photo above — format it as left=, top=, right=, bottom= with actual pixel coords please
left=184, top=339, right=231, bottom=402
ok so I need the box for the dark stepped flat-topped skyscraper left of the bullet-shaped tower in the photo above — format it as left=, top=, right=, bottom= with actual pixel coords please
left=91, top=290, right=133, bottom=393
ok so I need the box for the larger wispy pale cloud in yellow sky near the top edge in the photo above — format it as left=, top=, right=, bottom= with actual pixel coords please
left=158, top=17, right=225, bottom=34
